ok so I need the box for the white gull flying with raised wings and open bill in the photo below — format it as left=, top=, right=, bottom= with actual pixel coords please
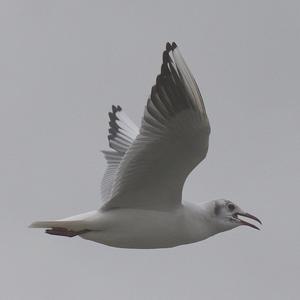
left=30, top=43, right=261, bottom=249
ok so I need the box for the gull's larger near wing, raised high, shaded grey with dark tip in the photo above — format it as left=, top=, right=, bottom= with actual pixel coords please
left=102, top=43, right=210, bottom=210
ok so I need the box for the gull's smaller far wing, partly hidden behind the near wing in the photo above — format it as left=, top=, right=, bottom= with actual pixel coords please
left=101, top=105, right=139, bottom=201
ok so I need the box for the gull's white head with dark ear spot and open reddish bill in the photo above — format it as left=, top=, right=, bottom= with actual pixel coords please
left=212, top=199, right=262, bottom=231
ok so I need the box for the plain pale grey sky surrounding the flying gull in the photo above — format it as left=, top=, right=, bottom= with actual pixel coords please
left=0, top=0, right=300, bottom=300
